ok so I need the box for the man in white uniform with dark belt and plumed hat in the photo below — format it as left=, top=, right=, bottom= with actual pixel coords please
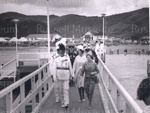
left=55, top=43, right=72, bottom=109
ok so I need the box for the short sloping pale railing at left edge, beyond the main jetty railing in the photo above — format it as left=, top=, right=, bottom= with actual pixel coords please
left=0, top=58, right=17, bottom=81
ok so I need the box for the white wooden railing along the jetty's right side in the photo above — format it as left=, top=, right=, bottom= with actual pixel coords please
left=98, top=60, right=143, bottom=113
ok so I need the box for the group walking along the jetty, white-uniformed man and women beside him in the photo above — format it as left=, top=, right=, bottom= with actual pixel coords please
left=50, top=43, right=99, bottom=109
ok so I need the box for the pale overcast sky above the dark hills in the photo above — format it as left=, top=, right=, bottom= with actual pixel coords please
left=0, top=0, right=149, bottom=16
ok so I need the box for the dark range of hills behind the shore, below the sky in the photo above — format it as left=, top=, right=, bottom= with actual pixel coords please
left=0, top=8, right=149, bottom=38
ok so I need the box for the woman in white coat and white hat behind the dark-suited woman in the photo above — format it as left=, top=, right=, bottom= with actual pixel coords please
left=73, top=45, right=86, bottom=101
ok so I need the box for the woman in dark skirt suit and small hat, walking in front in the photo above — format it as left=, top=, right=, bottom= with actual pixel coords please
left=81, top=54, right=99, bottom=109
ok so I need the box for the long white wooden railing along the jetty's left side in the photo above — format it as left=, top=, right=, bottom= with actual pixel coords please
left=0, top=63, right=53, bottom=113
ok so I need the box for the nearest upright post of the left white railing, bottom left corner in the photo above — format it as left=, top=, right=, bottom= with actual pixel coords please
left=6, top=91, right=13, bottom=113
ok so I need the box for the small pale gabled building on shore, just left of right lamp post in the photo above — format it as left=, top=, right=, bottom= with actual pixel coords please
left=82, top=31, right=108, bottom=42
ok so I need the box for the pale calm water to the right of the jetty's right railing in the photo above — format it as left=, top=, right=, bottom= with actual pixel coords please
left=106, top=54, right=149, bottom=108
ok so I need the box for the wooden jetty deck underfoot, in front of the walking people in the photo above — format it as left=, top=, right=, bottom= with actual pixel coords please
left=39, top=85, right=104, bottom=113
